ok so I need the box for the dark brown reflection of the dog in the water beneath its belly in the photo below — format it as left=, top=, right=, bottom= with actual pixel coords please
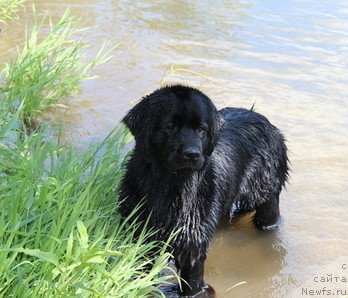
left=206, top=215, right=287, bottom=297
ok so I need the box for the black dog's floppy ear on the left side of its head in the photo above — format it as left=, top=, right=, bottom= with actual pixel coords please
left=122, top=97, right=150, bottom=141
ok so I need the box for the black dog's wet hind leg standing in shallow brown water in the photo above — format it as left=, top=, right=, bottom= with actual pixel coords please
left=253, top=193, right=280, bottom=230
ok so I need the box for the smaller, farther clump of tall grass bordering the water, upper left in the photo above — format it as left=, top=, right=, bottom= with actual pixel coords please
left=0, top=8, right=110, bottom=123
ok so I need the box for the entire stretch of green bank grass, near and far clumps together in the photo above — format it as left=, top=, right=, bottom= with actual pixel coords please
left=0, top=4, right=174, bottom=297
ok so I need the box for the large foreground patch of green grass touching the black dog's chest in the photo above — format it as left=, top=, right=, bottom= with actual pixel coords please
left=0, top=124, right=173, bottom=297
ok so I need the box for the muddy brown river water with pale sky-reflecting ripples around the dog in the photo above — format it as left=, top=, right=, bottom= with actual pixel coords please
left=0, top=0, right=348, bottom=297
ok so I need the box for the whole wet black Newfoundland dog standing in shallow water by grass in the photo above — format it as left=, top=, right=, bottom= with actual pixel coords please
left=120, top=85, right=288, bottom=296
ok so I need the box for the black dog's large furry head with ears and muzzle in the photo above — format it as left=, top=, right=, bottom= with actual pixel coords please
left=122, top=85, right=221, bottom=171
